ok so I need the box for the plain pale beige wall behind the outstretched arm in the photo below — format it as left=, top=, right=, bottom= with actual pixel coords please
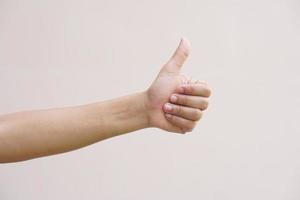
left=0, top=0, right=300, bottom=200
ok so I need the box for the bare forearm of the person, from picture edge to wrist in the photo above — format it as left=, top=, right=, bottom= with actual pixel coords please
left=0, top=93, right=148, bottom=162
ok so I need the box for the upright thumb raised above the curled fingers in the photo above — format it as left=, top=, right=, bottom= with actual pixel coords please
left=162, top=38, right=190, bottom=73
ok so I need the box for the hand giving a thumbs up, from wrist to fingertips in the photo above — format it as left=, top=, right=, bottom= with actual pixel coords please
left=146, top=39, right=211, bottom=133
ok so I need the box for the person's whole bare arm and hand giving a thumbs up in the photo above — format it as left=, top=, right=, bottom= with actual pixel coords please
left=0, top=39, right=211, bottom=163
